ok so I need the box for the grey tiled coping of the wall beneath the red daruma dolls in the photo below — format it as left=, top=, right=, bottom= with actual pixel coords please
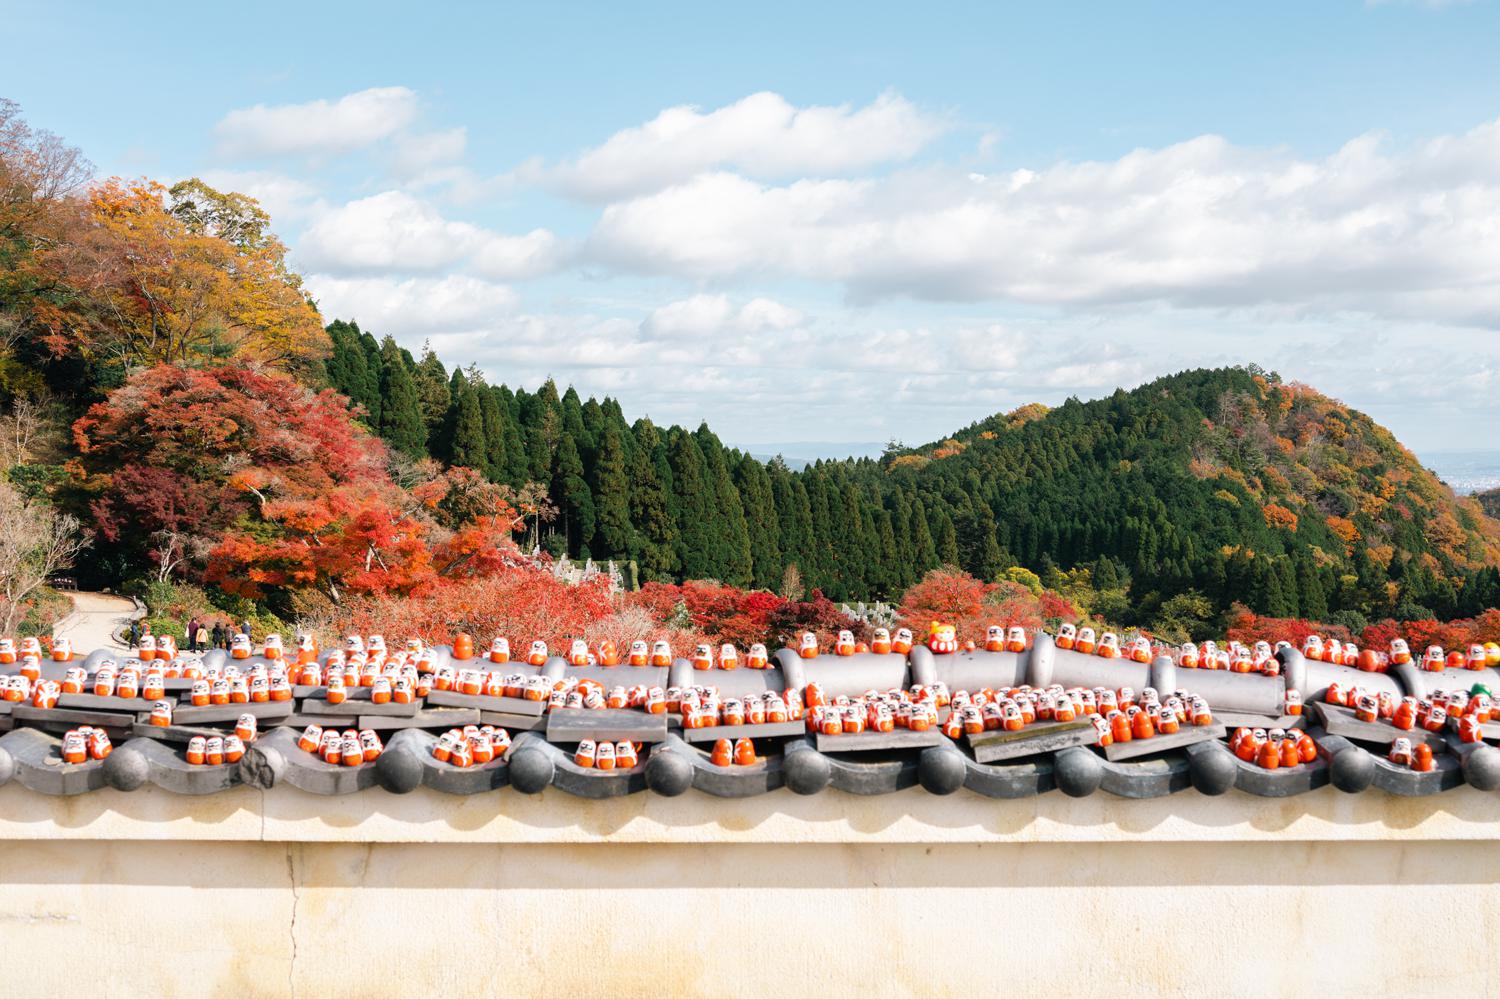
left=0, top=635, right=1500, bottom=807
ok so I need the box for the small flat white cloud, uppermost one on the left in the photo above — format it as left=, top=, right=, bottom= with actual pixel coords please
left=215, top=87, right=417, bottom=159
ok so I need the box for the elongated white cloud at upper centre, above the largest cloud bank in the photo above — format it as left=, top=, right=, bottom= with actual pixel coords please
left=534, top=93, right=948, bottom=201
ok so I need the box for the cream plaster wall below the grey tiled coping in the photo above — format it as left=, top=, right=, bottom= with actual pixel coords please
left=0, top=788, right=1500, bottom=998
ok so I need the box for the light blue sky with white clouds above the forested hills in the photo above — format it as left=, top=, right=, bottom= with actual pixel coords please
left=0, top=0, right=1500, bottom=450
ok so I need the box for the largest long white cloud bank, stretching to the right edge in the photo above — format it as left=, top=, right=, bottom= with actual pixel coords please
left=588, top=122, right=1500, bottom=323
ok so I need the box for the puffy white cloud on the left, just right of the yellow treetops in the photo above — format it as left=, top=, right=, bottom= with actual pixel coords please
left=297, top=191, right=564, bottom=281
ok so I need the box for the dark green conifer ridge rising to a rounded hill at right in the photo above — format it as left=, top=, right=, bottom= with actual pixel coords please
left=319, top=323, right=1500, bottom=624
